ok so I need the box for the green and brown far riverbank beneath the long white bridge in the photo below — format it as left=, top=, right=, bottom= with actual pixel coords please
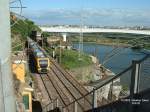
left=68, top=33, right=150, bottom=49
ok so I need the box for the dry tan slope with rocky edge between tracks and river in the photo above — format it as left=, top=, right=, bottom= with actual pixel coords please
left=70, top=55, right=115, bottom=85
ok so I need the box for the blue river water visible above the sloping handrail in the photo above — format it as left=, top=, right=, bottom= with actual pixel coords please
left=73, top=43, right=145, bottom=73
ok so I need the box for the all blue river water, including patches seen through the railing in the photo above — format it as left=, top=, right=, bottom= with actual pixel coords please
left=73, top=43, right=150, bottom=90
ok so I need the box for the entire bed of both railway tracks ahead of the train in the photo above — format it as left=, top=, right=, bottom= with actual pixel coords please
left=33, top=57, right=92, bottom=112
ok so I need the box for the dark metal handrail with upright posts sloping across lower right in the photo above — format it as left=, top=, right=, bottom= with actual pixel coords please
left=63, top=54, right=150, bottom=112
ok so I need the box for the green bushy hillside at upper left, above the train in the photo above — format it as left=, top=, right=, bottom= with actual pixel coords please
left=11, top=18, right=40, bottom=51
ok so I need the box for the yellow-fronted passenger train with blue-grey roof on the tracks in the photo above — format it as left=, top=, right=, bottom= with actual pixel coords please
left=28, top=38, right=50, bottom=73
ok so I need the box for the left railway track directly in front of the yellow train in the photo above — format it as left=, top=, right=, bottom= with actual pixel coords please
left=37, top=74, right=71, bottom=112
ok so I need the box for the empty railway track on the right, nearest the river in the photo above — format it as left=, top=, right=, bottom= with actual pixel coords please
left=50, top=59, right=92, bottom=111
